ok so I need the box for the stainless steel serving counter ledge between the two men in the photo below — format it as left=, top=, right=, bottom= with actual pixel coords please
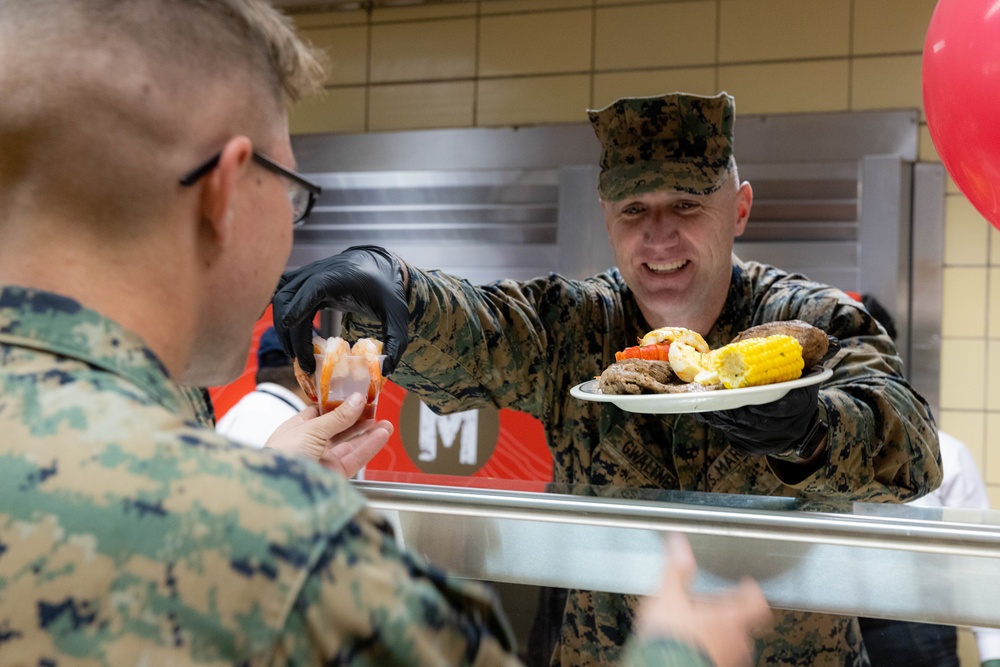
left=355, top=482, right=1000, bottom=627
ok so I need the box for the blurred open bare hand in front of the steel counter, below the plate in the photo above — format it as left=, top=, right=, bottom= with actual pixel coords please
left=636, top=534, right=772, bottom=667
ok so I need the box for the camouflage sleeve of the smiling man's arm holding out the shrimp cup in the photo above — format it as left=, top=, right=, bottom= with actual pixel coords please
left=345, top=266, right=599, bottom=419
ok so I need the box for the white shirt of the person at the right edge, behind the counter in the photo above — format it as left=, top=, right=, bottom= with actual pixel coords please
left=909, top=431, right=1000, bottom=662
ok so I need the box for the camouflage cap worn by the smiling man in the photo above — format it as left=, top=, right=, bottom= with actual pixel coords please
left=587, top=93, right=734, bottom=201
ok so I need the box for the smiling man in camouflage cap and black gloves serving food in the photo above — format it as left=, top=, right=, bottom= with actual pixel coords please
left=273, top=94, right=941, bottom=667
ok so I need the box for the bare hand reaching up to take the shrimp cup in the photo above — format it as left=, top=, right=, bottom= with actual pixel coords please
left=265, top=394, right=393, bottom=477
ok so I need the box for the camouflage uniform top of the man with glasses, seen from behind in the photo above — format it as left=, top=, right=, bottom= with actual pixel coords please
left=0, top=287, right=515, bottom=667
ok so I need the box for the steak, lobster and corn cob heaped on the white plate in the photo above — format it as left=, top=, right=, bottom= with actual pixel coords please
left=598, top=320, right=831, bottom=394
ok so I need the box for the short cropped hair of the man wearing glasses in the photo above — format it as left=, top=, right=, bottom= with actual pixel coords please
left=0, top=0, right=324, bottom=227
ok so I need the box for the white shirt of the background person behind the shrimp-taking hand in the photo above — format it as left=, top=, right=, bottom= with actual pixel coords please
left=215, top=382, right=306, bottom=448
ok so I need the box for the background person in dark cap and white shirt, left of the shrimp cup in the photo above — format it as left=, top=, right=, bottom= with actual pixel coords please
left=215, top=327, right=308, bottom=447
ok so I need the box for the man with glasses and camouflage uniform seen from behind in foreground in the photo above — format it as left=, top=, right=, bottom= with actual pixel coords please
left=0, top=0, right=768, bottom=667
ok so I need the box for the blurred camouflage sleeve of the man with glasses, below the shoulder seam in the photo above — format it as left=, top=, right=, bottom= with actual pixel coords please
left=285, top=509, right=520, bottom=667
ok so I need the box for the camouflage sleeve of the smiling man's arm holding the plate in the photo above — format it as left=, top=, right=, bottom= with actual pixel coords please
left=761, top=276, right=941, bottom=502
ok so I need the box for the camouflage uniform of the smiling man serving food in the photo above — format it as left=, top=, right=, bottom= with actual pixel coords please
left=346, top=257, right=941, bottom=667
